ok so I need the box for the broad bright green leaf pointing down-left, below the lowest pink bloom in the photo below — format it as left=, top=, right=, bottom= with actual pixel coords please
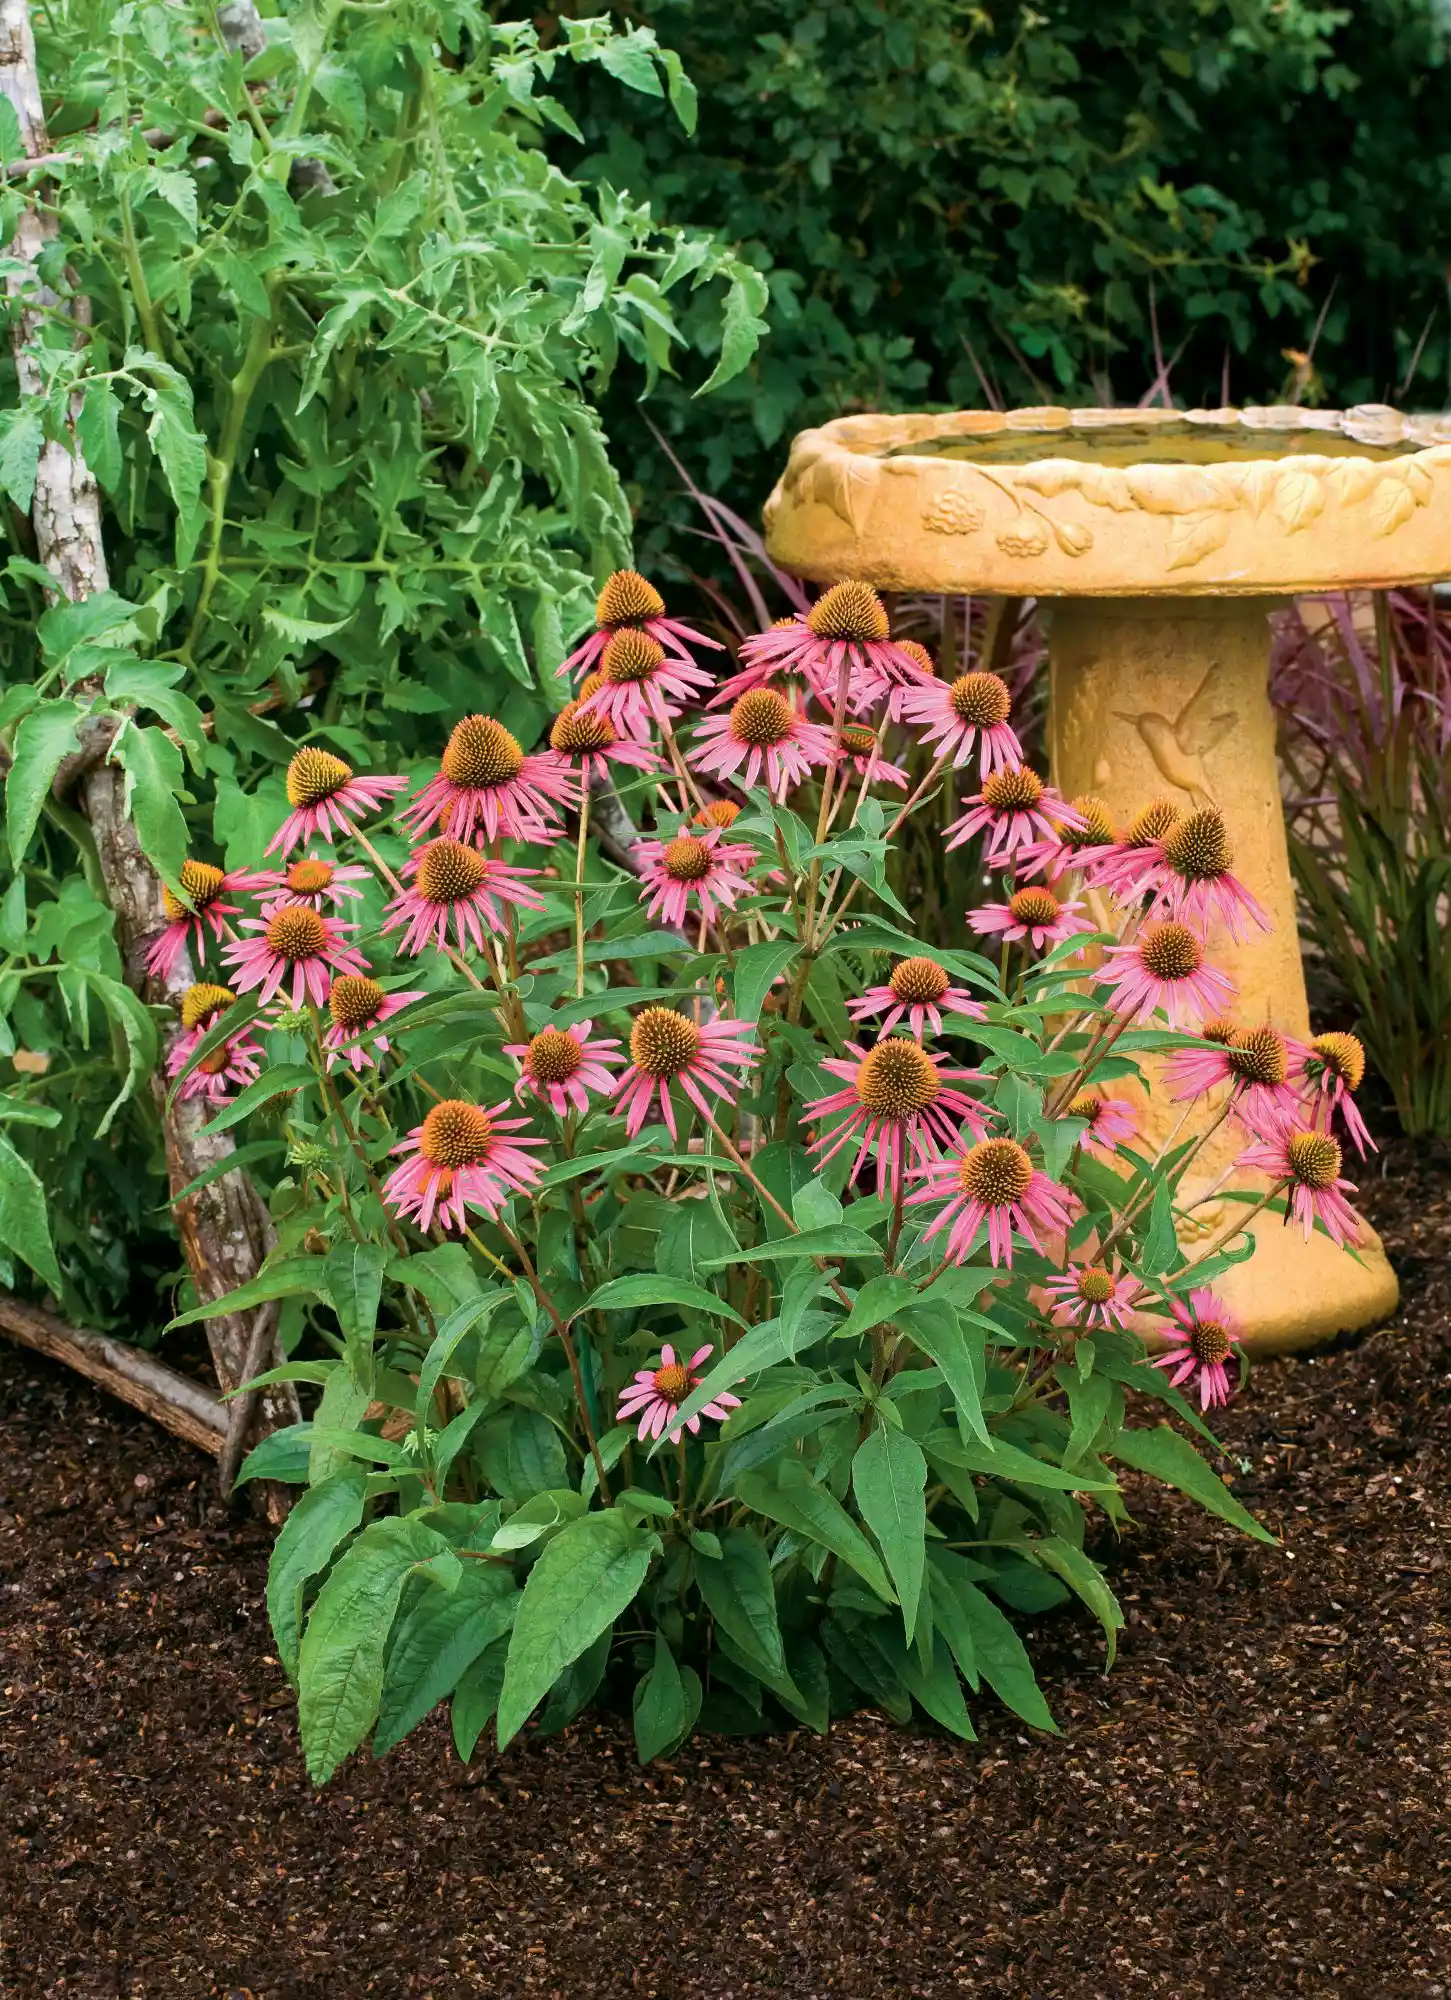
left=498, top=1510, right=658, bottom=1750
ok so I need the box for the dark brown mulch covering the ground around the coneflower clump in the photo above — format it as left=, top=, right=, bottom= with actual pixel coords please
left=0, top=1148, right=1451, bottom=2000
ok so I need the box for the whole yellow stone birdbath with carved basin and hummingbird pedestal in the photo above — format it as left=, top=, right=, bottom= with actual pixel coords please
left=765, top=404, right=1451, bottom=1352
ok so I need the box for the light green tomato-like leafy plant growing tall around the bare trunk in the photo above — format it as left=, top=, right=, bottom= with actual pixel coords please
left=0, top=0, right=761, bottom=1324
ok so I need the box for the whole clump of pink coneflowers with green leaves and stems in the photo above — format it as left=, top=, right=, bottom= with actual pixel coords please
left=170, top=572, right=1369, bottom=1780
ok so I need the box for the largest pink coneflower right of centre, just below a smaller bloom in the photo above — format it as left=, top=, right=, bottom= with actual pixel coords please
left=803, top=1034, right=993, bottom=1200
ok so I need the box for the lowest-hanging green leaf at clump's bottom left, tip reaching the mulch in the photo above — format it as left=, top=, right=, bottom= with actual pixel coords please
left=298, top=1516, right=452, bottom=1784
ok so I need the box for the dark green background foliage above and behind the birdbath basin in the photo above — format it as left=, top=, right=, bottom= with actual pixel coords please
left=555, top=0, right=1451, bottom=540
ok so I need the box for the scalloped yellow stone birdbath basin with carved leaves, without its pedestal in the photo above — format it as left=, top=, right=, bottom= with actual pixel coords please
left=765, top=404, right=1451, bottom=598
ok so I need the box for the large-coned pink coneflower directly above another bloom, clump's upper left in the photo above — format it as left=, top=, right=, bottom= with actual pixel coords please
left=398, top=716, right=580, bottom=844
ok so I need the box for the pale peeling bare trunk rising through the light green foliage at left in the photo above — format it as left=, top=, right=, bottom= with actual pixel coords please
left=0, top=0, right=302, bottom=1520
